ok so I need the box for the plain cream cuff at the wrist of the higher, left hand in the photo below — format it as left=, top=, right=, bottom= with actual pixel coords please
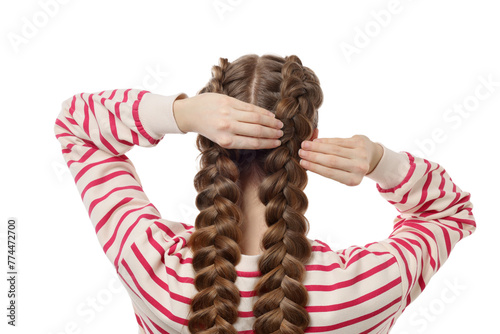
left=139, top=93, right=188, bottom=139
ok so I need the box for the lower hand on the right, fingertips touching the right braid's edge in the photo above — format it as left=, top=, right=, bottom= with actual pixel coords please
left=299, top=135, right=384, bottom=187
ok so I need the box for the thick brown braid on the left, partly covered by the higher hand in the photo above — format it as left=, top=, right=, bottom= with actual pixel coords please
left=188, top=56, right=241, bottom=334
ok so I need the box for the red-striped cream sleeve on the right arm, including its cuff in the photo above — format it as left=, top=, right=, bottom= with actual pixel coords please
left=367, top=145, right=476, bottom=315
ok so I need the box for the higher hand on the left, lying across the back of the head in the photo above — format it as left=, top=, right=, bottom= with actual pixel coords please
left=173, top=93, right=283, bottom=150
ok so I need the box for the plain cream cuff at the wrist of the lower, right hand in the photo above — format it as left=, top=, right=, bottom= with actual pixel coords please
left=366, top=142, right=410, bottom=189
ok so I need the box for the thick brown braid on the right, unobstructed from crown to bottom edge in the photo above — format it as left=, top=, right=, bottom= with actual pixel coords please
left=253, top=56, right=316, bottom=334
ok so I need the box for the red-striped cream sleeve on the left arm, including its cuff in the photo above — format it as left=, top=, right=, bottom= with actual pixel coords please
left=54, top=89, right=190, bottom=269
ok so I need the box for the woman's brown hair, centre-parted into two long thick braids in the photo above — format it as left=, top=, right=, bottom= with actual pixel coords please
left=188, top=55, right=323, bottom=334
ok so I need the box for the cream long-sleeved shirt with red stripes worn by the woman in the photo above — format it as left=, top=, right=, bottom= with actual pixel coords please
left=54, top=89, right=476, bottom=334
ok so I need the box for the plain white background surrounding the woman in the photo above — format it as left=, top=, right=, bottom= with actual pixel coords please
left=0, top=0, right=500, bottom=334
